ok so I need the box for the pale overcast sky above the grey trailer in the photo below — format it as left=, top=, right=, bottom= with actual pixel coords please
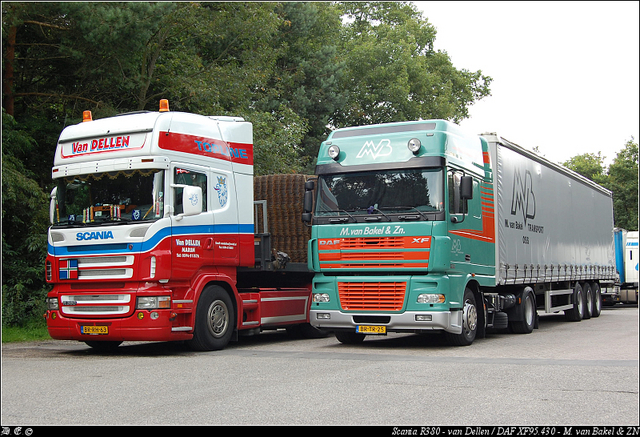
left=414, top=1, right=640, bottom=164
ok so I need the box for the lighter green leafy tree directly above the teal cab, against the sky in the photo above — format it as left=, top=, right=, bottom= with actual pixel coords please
left=331, top=2, right=492, bottom=127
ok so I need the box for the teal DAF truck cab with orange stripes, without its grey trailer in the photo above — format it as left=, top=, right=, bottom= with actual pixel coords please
left=303, top=120, right=496, bottom=345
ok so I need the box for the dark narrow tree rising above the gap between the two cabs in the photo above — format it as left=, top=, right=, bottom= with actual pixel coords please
left=256, top=2, right=346, bottom=171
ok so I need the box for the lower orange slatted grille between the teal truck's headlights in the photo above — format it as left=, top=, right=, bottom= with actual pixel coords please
left=338, top=282, right=407, bottom=311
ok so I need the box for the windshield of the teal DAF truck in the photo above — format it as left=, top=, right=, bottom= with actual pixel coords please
left=315, top=169, right=444, bottom=219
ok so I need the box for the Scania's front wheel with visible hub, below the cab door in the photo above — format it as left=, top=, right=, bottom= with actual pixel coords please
left=189, top=285, right=235, bottom=351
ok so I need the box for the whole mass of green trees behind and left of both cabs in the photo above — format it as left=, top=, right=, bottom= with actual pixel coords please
left=2, top=2, right=498, bottom=324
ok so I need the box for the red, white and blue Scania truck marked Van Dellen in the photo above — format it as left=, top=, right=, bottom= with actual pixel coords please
left=45, top=101, right=313, bottom=350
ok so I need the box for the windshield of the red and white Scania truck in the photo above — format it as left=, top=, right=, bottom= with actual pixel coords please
left=54, top=169, right=164, bottom=225
